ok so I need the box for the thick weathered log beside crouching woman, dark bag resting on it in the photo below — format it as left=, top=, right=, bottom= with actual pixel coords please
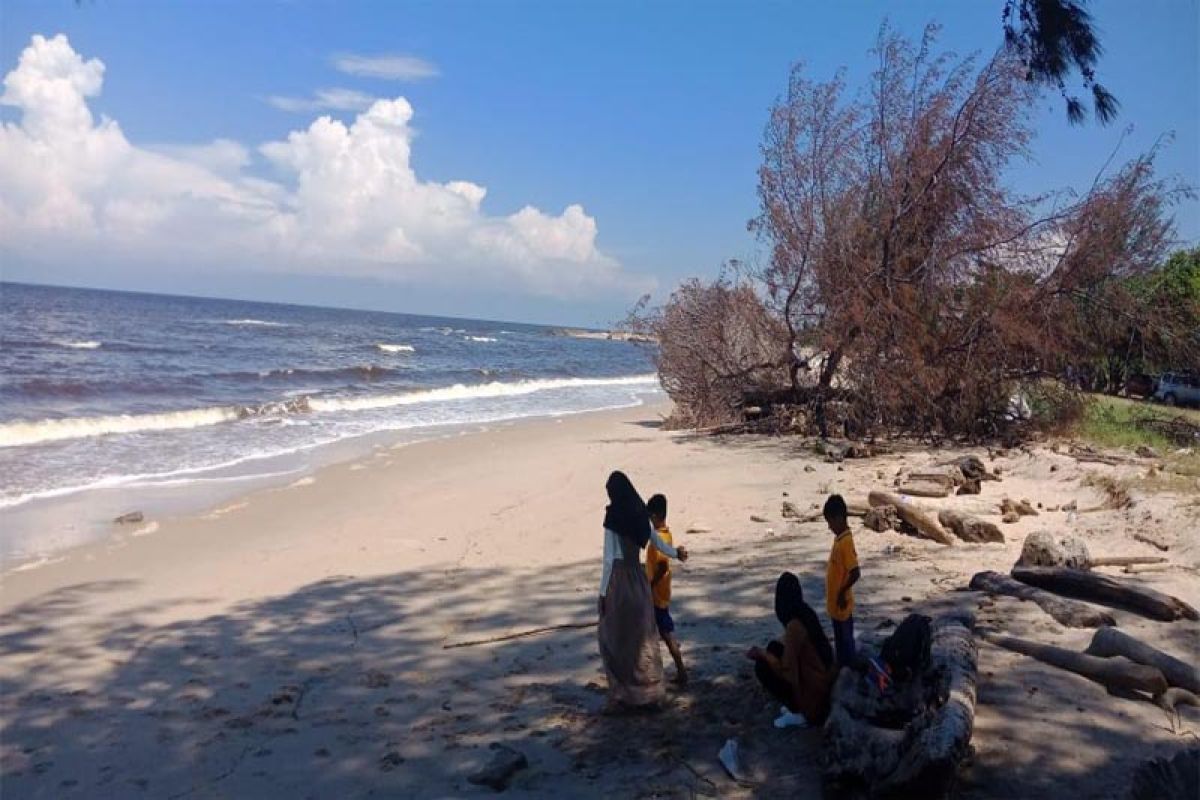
left=822, top=614, right=978, bottom=798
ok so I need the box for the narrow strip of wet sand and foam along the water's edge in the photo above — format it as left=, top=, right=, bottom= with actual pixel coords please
left=0, top=391, right=666, bottom=568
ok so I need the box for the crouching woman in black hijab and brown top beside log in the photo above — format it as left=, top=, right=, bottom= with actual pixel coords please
left=746, top=572, right=838, bottom=728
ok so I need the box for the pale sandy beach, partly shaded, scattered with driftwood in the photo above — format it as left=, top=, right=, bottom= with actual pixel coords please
left=0, top=405, right=1200, bottom=798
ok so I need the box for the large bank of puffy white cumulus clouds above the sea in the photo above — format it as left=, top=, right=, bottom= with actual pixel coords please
left=0, top=35, right=646, bottom=296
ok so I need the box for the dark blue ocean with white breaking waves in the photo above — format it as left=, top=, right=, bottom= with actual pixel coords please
left=0, top=283, right=659, bottom=561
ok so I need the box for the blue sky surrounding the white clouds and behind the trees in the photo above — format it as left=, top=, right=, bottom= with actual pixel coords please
left=0, top=0, right=1200, bottom=324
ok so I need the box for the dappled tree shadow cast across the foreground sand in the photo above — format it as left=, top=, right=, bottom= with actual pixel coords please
left=0, top=527, right=1190, bottom=799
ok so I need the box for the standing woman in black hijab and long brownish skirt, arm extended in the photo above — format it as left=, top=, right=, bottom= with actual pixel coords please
left=598, top=471, right=688, bottom=706
